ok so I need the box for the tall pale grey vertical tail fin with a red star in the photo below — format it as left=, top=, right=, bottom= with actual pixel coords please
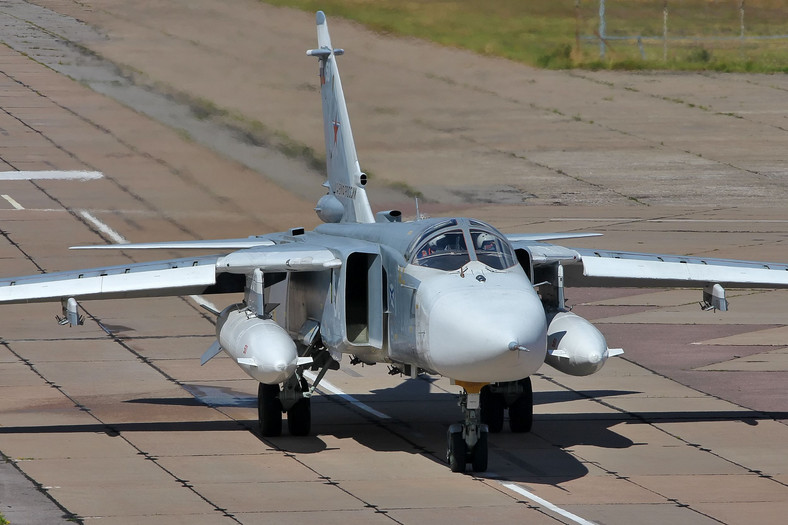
left=306, top=11, right=375, bottom=222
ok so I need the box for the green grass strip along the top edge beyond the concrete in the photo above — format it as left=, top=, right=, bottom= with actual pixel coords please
left=265, top=0, right=788, bottom=72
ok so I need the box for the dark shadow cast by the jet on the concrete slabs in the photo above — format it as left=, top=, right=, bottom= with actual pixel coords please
left=0, top=381, right=788, bottom=483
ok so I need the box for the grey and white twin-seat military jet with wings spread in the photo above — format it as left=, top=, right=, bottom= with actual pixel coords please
left=0, top=12, right=788, bottom=472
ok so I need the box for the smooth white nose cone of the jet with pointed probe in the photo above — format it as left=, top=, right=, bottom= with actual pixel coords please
left=424, top=289, right=547, bottom=382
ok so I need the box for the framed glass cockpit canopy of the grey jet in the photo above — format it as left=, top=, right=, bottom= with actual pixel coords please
left=409, top=219, right=517, bottom=271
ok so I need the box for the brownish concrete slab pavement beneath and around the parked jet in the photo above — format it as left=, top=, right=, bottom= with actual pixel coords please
left=0, top=0, right=788, bottom=525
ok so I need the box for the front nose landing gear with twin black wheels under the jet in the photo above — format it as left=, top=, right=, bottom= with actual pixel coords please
left=446, top=381, right=488, bottom=472
